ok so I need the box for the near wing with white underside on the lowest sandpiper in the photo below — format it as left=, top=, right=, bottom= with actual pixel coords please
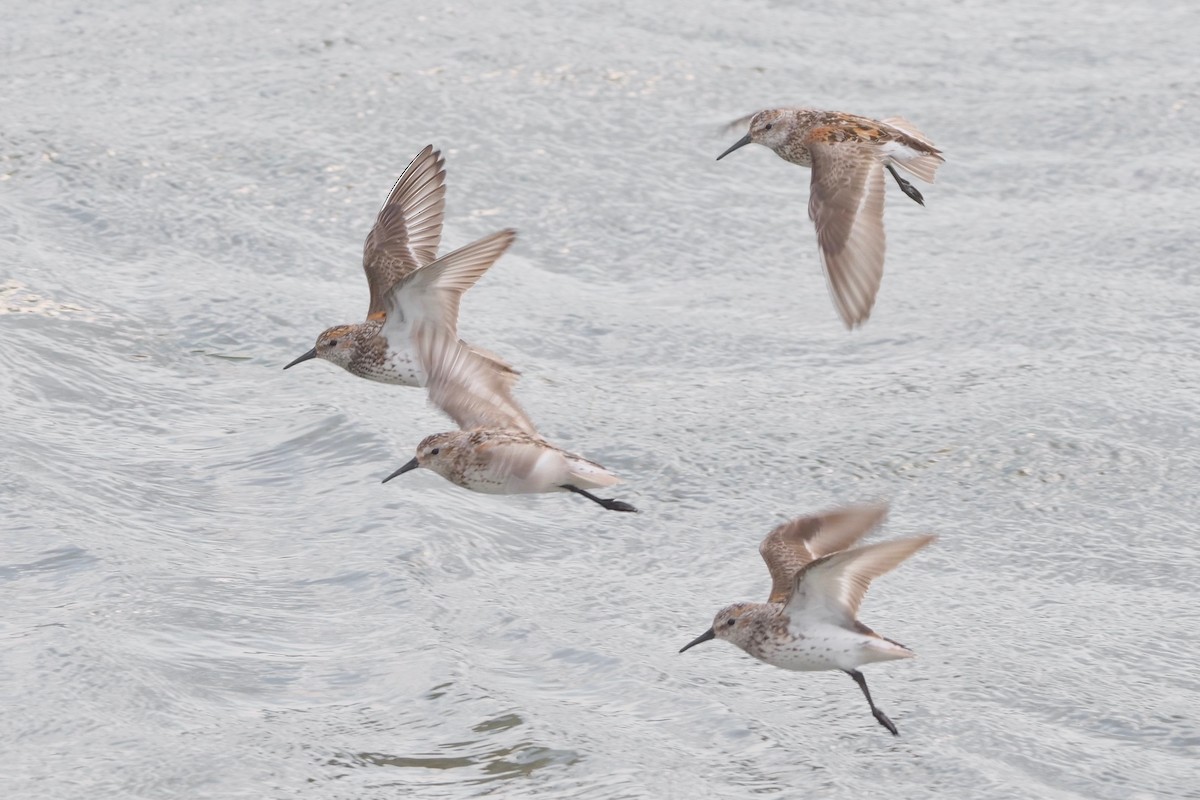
left=784, top=535, right=937, bottom=626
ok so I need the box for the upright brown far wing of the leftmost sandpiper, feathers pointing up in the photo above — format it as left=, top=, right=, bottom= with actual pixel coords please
left=362, top=145, right=446, bottom=314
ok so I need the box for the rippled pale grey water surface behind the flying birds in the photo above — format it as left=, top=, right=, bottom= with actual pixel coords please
left=0, top=0, right=1200, bottom=799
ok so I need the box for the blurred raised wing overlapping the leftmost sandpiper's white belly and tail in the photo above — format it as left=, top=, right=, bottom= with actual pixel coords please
left=414, top=325, right=538, bottom=435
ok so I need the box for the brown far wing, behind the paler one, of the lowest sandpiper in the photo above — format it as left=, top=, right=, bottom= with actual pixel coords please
left=758, top=503, right=888, bottom=603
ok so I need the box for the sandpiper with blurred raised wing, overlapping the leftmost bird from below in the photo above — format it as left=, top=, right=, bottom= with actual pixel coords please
left=383, top=326, right=637, bottom=511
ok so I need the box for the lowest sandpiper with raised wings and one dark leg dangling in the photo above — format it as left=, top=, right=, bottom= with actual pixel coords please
left=679, top=505, right=936, bottom=735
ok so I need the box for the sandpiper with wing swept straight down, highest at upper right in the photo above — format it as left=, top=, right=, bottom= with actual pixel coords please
left=716, top=108, right=946, bottom=327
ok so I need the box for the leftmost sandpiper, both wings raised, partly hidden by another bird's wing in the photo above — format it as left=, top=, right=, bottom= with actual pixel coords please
left=283, top=145, right=515, bottom=386
